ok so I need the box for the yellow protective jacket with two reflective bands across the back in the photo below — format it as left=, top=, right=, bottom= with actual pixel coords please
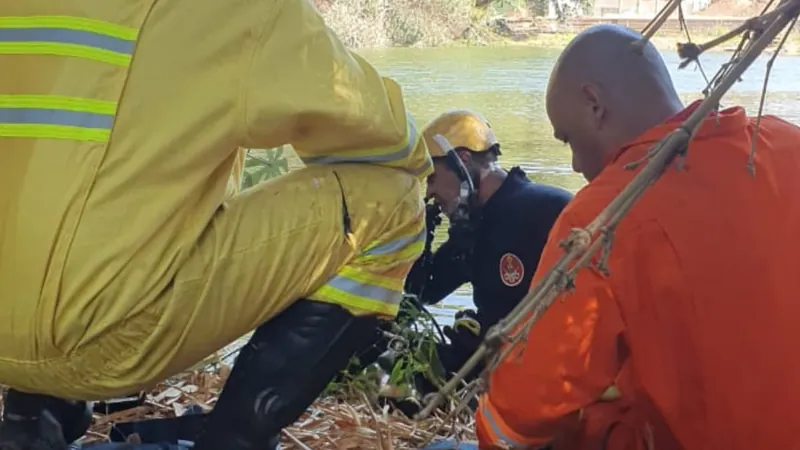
left=0, top=0, right=431, bottom=394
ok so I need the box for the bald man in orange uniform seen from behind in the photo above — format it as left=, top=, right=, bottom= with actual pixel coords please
left=477, top=25, right=800, bottom=450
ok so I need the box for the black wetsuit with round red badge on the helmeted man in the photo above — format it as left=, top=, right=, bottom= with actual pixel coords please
left=406, top=167, right=572, bottom=378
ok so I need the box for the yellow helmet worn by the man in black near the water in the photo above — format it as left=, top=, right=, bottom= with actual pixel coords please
left=422, top=109, right=497, bottom=158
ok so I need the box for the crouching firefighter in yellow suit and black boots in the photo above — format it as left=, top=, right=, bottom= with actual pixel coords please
left=0, top=0, right=431, bottom=450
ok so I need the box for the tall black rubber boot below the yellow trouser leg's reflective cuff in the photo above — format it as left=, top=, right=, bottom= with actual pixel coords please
left=194, top=299, right=378, bottom=450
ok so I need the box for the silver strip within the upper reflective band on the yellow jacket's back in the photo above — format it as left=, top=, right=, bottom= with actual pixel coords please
left=0, top=28, right=136, bottom=55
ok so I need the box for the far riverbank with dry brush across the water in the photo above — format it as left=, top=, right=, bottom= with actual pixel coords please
left=315, top=0, right=800, bottom=55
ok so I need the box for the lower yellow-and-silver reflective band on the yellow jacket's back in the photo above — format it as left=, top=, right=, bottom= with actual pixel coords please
left=0, top=95, right=117, bottom=142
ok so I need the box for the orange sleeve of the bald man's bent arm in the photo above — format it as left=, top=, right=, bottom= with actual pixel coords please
left=476, top=211, right=623, bottom=449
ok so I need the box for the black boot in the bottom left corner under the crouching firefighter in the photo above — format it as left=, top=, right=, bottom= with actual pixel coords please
left=0, top=389, right=92, bottom=446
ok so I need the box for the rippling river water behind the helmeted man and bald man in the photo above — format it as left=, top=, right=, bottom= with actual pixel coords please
left=350, top=46, right=800, bottom=321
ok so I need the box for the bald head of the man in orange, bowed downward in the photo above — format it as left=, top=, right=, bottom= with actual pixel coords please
left=547, top=24, right=682, bottom=180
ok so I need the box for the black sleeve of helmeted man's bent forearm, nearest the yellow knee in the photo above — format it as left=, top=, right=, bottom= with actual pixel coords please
left=406, top=241, right=470, bottom=305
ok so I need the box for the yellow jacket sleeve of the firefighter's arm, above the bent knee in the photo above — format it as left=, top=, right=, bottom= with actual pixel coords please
left=243, top=0, right=432, bottom=178
